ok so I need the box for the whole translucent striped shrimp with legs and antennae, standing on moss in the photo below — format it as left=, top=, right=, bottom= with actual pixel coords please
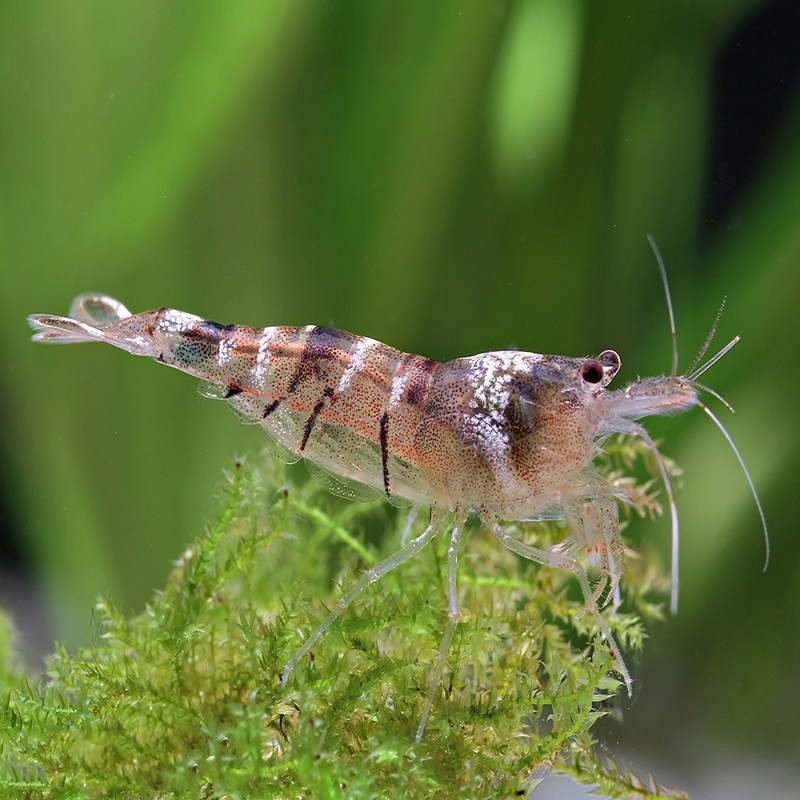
left=28, top=239, right=769, bottom=742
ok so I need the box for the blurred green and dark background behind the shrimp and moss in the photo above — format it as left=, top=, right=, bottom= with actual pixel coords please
left=0, top=0, right=800, bottom=797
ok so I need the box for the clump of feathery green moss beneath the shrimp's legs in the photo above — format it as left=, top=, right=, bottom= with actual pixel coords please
left=0, top=443, right=688, bottom=799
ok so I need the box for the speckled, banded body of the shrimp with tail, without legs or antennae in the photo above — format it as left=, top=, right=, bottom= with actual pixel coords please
left=31, top=295, right=632, bottom=520
